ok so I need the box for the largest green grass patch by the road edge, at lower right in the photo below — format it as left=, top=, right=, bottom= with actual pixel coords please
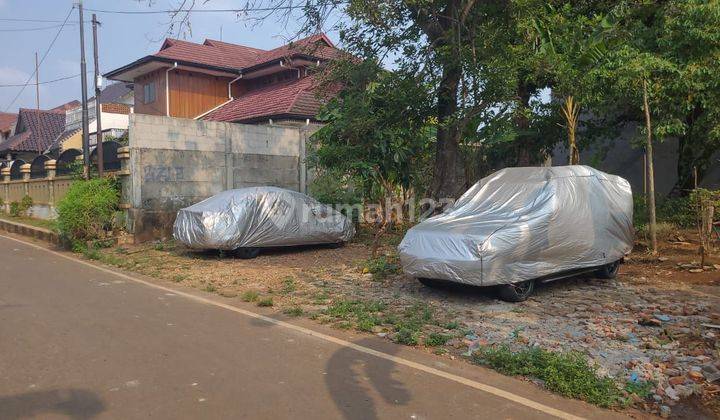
left=472, top=346, right=622, bottom=407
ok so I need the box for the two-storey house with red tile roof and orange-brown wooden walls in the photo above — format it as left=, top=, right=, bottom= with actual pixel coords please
left=105, top=34, right=341, bottom=124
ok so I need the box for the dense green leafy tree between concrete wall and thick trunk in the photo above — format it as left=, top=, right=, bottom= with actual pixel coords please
left=309, top=61, right=433, bottom=202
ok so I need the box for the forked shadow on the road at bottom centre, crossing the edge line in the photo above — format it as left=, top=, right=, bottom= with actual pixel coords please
left=325, top=338, right=411, bottom=420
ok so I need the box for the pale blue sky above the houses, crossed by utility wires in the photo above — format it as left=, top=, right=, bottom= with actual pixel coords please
left=0, top=0, right=338, bottom=112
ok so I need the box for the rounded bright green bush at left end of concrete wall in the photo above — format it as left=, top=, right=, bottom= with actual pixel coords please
left=57, top=178, right=120, bottom=242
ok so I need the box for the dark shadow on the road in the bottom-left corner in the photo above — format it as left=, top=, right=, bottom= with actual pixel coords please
left=0, top=389, right=105, bottom=420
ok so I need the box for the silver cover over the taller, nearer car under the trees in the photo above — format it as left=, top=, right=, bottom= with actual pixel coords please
left=398, top=166, right=634, bottom=286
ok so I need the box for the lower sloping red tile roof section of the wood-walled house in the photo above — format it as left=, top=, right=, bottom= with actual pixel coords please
left=203, top=76, right=328, bottom=122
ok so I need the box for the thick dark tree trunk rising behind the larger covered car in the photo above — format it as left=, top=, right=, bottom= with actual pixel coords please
left=432, top=63, right=462, bottom=199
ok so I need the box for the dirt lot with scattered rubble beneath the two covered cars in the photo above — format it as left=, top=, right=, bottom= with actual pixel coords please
left=87, top=228, right=720, bottom=418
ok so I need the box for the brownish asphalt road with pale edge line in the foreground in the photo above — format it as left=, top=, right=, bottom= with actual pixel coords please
left=0, top=236, right=628, bottom=419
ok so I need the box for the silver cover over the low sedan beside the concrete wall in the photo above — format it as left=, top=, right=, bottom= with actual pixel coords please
left=173, top=187, right=355, bottom=250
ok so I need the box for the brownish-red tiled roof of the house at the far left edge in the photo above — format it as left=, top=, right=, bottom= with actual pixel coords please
left=0, top=108, right=65, bottom=153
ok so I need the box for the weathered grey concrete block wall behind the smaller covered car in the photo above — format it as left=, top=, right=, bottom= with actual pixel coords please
left=123, top=114, right=307, bottom=240
